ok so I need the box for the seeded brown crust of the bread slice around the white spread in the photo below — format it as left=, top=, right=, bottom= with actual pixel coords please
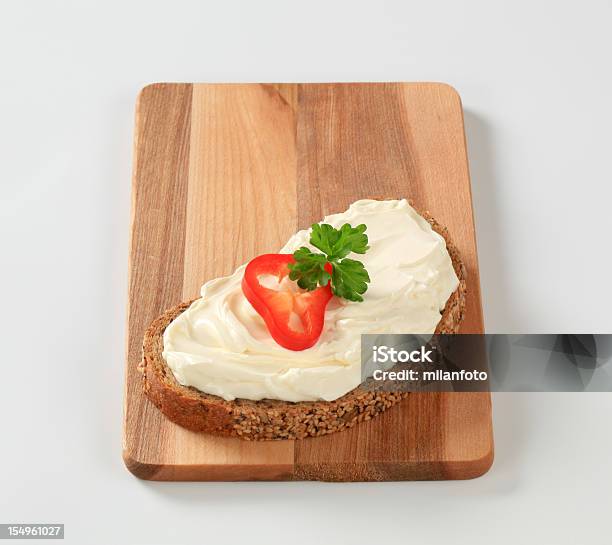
left=140, top=210, right=466, bottom=440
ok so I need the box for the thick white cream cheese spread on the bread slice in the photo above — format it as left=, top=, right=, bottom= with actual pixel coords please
left=163, top=199, right=459, bottom=402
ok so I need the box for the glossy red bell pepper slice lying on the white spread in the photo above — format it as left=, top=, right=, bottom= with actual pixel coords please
left=242, top=254, right=332, bottom=350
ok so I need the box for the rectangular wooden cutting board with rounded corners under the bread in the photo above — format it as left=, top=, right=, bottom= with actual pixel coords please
left=123, top=83, right=493, bottom=481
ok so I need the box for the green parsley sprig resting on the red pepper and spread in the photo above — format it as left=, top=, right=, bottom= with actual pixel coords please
left=289, top=223, right=370, bottom=301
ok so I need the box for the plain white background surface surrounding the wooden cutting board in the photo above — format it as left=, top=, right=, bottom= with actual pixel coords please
left=0, top=0, right=612, bottom=544
